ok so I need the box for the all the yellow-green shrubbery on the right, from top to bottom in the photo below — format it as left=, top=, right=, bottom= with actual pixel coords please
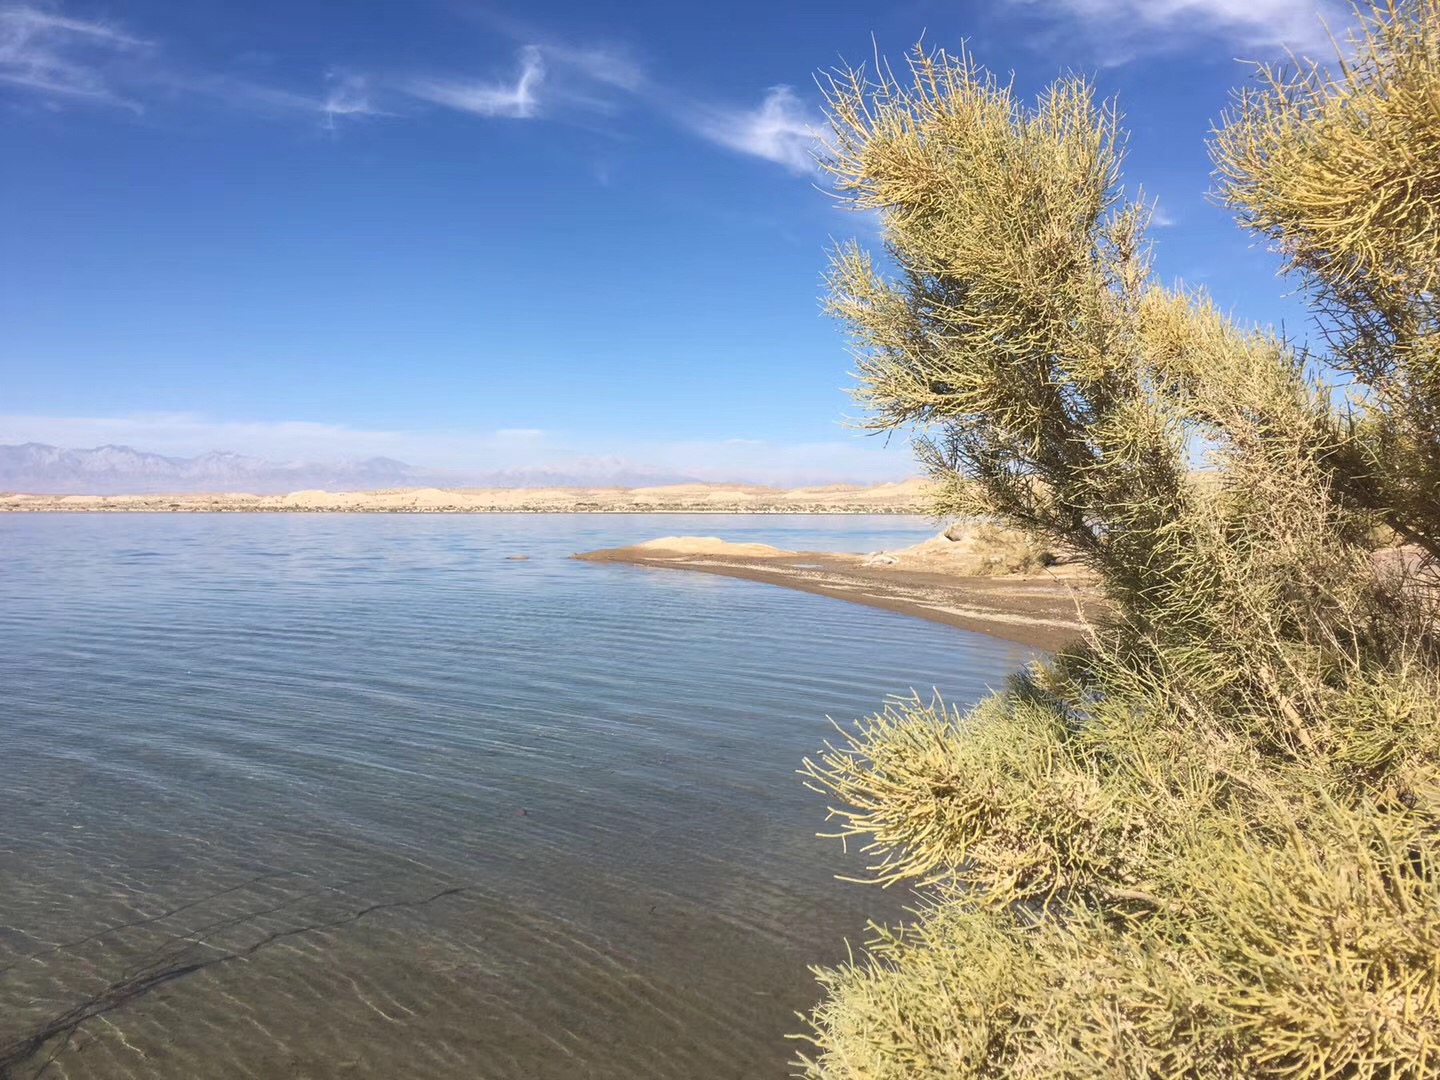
left=799, top=0, right=1440, bottom=1080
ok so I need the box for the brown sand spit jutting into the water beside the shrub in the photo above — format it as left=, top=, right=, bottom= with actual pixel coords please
left=576, top=530, right=1099, bottom=649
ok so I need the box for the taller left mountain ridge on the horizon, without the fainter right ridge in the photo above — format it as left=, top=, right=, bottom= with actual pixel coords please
left=0, top=442, right=436, bottom=495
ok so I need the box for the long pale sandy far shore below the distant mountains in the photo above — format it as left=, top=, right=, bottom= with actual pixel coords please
left=0, top=480, right=926, bottom=514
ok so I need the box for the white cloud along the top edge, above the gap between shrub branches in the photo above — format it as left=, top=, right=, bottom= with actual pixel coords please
left=1011, top=0, right=1349, bottom=60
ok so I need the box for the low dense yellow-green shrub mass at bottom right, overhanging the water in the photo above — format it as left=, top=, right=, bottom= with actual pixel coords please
left=806, top=678, right=1440, bottom=1080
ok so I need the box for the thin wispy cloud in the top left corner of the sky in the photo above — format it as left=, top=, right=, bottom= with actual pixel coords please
left=0, top=7, right=148, bottom=109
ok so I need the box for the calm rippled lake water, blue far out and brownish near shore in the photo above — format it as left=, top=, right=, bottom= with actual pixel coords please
left=0, top=514, right=1027, bottom=1080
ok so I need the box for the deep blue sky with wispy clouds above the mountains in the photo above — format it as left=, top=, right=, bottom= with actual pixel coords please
left=0, top=0, right=1345, bottom=482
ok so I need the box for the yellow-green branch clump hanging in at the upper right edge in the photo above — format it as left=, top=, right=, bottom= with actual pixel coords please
left=1214, top=0, right=1440, bottom=554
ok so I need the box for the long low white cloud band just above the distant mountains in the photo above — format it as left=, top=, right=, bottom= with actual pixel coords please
left=0, top=413, right=916, bottom=485
